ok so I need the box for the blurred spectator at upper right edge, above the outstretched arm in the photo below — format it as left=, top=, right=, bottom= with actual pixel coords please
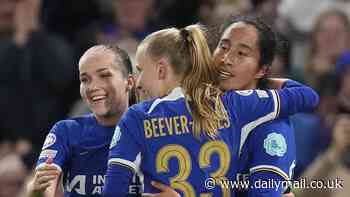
left=305, top=10, right=350, bottom=89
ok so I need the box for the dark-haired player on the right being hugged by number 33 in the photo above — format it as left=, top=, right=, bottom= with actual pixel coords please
left=148, top=16, right=295, bottom=197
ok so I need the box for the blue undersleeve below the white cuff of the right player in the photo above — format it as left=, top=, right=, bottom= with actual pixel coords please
left=248, top=172, right=285, bottom=197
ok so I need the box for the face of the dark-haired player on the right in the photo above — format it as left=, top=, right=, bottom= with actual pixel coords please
left=213, top=22, right=265, bottom=90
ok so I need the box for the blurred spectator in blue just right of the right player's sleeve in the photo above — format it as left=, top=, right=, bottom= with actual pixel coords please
left=291, top=76, right=337, bottom=177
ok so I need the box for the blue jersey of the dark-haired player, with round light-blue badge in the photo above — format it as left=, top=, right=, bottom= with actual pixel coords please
left=237, top=118, right=296, bottom=197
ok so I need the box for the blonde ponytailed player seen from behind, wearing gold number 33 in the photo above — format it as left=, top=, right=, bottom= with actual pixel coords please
left=104, top=25, right=318, bottom=196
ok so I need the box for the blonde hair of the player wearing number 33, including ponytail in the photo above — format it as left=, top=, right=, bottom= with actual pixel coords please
left=138, top=25, right=227, bottom=138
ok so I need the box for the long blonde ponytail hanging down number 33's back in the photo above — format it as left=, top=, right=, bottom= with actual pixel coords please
left=180, top=25, right=227, bottom=138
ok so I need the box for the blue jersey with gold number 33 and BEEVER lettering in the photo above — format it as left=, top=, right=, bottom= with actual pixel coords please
left=105, top=84, right=318, bottom=197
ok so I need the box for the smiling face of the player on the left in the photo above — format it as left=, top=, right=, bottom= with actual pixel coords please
left=79, top=47, right=128, bottom=120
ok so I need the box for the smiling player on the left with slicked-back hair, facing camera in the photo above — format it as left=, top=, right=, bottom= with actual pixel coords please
left=28, top=45, right=139, bottom=196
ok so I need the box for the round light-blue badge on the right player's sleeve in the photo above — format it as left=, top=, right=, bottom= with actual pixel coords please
left=264, top=133, right=287, bottom=157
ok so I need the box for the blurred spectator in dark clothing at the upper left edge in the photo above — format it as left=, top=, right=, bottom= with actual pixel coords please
left=0, top=0, right=76, bottom=150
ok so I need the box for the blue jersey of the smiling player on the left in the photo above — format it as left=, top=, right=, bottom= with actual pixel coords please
left=37, top=114, right=142, bottom=197
